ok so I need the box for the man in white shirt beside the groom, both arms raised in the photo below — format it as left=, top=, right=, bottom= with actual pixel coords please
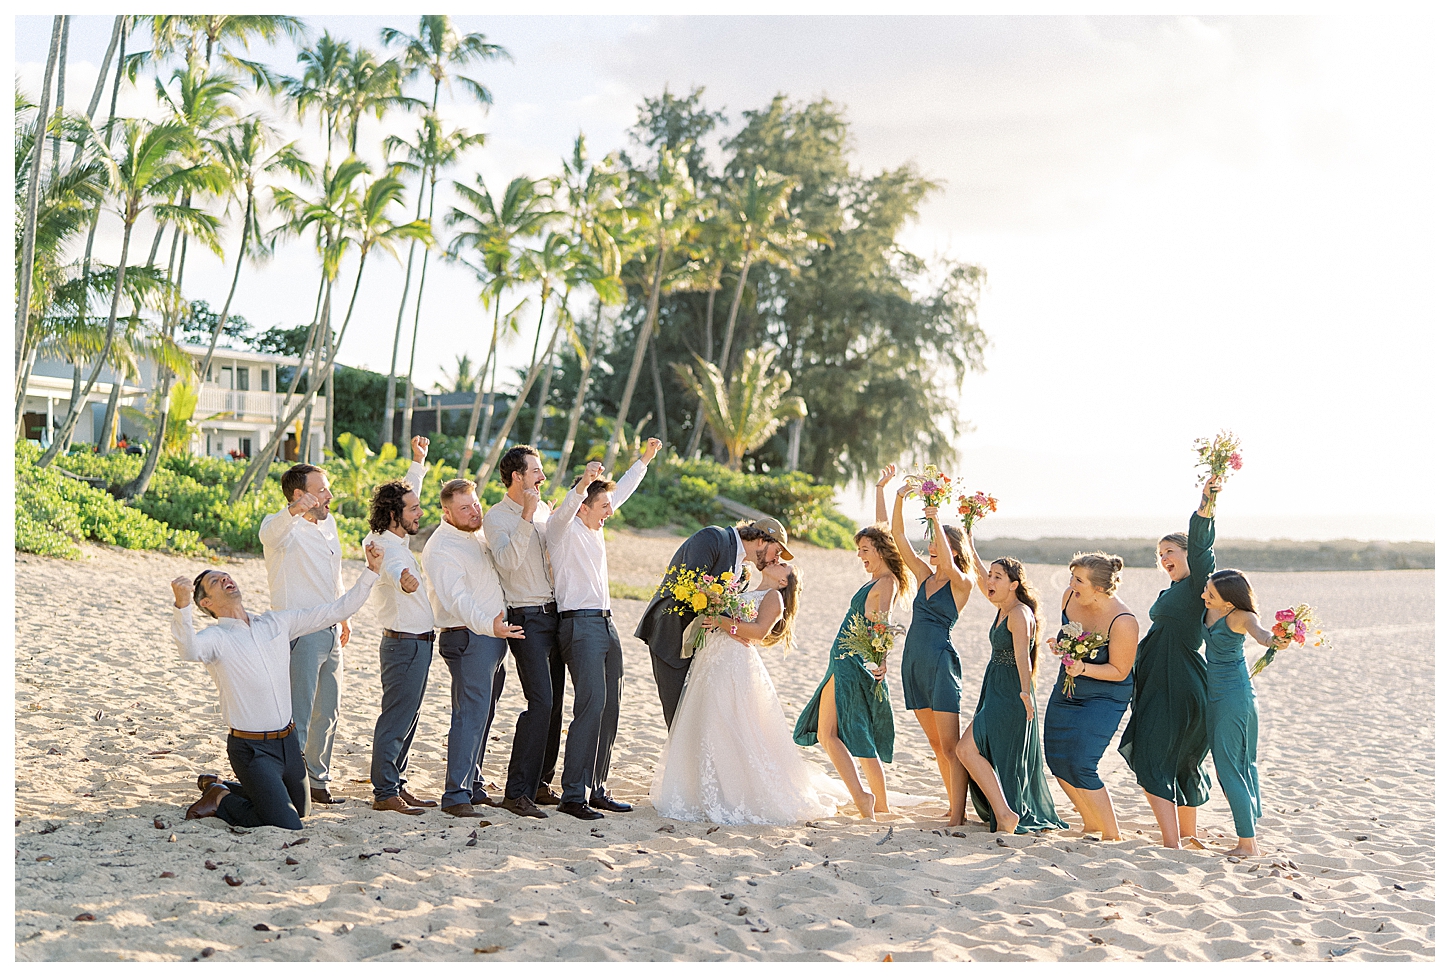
left=547, top=438, right=661, bottom=820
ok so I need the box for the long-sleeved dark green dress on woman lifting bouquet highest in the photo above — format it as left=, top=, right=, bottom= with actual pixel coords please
left=1118, top=512, right=1214, bottom=807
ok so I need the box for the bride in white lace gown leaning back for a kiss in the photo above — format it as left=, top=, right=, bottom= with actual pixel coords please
left=650, top=564, right=850, bottom=825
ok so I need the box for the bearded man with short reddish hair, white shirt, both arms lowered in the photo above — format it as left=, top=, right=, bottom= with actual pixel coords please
left=423, top=478, right=523, bottom=818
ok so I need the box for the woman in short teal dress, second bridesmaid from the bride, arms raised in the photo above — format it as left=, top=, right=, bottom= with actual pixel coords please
left=882, top=465, right=972, bottom=825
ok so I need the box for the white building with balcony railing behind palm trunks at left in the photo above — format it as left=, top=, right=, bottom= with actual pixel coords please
left=23, top=344, right=326, bottom=461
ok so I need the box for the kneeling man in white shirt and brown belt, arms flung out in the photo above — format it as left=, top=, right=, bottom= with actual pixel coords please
left=171, top=545, right=383, bottom=831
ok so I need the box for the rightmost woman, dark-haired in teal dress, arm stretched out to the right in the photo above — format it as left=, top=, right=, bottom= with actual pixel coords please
left=1204, top=570, right=1289, bottom=855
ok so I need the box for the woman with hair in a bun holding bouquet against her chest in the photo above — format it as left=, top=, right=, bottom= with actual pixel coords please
left=1043, top=552, right=1138, bottom=841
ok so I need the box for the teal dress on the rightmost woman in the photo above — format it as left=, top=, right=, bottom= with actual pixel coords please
left=1199, top=616, right=1263, bottom=838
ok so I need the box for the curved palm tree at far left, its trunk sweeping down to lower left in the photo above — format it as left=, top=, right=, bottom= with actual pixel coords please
left=36, top=119, right=226, bottom=467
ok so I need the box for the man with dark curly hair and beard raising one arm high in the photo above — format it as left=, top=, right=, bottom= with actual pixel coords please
left=367, top=436, right=438, bottom=815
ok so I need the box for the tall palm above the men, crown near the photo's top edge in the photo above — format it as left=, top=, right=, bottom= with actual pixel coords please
left=380, top=14, right=512, bottom=458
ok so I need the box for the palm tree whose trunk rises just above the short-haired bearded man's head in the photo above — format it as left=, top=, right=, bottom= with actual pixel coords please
left=444, top=175, right=557, bottom=471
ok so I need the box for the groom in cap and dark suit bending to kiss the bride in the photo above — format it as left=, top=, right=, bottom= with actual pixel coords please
left=635, top=516, right=790, bottom=726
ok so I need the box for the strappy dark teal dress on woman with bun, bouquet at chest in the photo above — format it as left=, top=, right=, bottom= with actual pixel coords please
left=1043, top=604, right=1132, bottom=790
